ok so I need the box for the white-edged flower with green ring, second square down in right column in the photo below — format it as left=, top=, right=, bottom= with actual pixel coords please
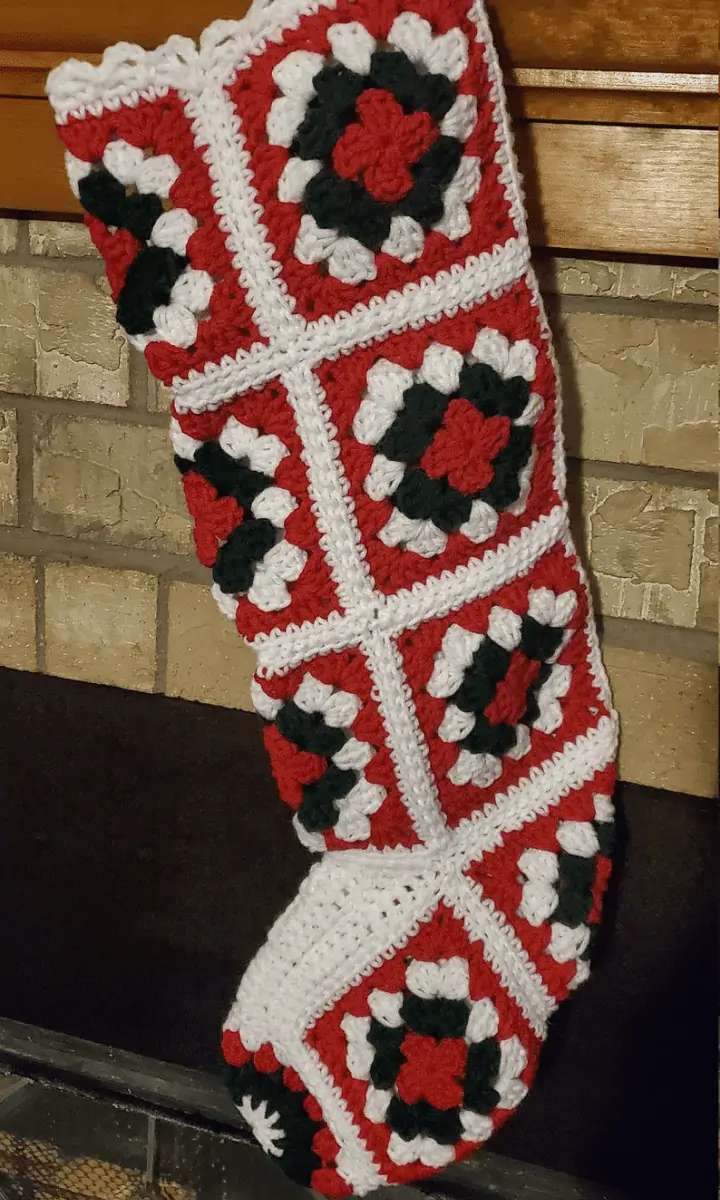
left=353, top=329, right=542, bottom=558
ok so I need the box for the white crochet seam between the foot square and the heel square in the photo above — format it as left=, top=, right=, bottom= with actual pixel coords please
left=444, top=871, right=557, bottom=1038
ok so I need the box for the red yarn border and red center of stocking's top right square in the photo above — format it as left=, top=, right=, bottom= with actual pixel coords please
left=228, top=0, right=517, bottom=320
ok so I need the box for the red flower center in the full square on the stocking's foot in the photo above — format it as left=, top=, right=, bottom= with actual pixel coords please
left=396, top=1033, right=468, bottom=1111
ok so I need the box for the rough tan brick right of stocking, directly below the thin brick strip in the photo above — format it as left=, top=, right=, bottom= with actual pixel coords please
left=554, top=311, right=718, bottom=470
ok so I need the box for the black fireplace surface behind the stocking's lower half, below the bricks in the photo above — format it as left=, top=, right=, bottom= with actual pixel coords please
left=0, top=672, right=716, bottom=1200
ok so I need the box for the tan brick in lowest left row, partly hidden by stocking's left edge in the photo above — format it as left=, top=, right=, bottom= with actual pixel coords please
left=166, top=582, right=254, bottom=712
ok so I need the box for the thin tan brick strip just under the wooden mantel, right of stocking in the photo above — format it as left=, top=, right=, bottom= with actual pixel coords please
left=536, top=256, right=718, bottom=305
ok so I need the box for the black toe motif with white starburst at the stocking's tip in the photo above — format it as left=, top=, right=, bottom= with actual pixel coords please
left=226, top=1062, right=323, bottom=1187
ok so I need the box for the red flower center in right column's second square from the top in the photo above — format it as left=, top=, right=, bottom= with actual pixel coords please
left=420, top=398, right=511, bottom=496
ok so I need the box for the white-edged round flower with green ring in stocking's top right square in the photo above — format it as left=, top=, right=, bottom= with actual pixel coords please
left=266, top=12, right=480, bottom=283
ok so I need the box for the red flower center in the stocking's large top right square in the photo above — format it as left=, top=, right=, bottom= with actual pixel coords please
left=332, top=88, right=438, bottom=204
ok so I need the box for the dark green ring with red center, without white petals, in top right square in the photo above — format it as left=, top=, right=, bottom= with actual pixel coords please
left=290, top=57, right=462, bottom=251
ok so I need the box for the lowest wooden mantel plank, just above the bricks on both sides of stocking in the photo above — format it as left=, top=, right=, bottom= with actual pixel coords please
left=0, top=98, right=718, bottom=258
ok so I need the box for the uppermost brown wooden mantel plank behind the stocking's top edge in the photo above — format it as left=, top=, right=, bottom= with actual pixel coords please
left=0, top=0, right=718, bottom=72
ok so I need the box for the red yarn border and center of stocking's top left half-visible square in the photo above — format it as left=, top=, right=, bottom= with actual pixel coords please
left=58, top=91, right=264, bottom=384
